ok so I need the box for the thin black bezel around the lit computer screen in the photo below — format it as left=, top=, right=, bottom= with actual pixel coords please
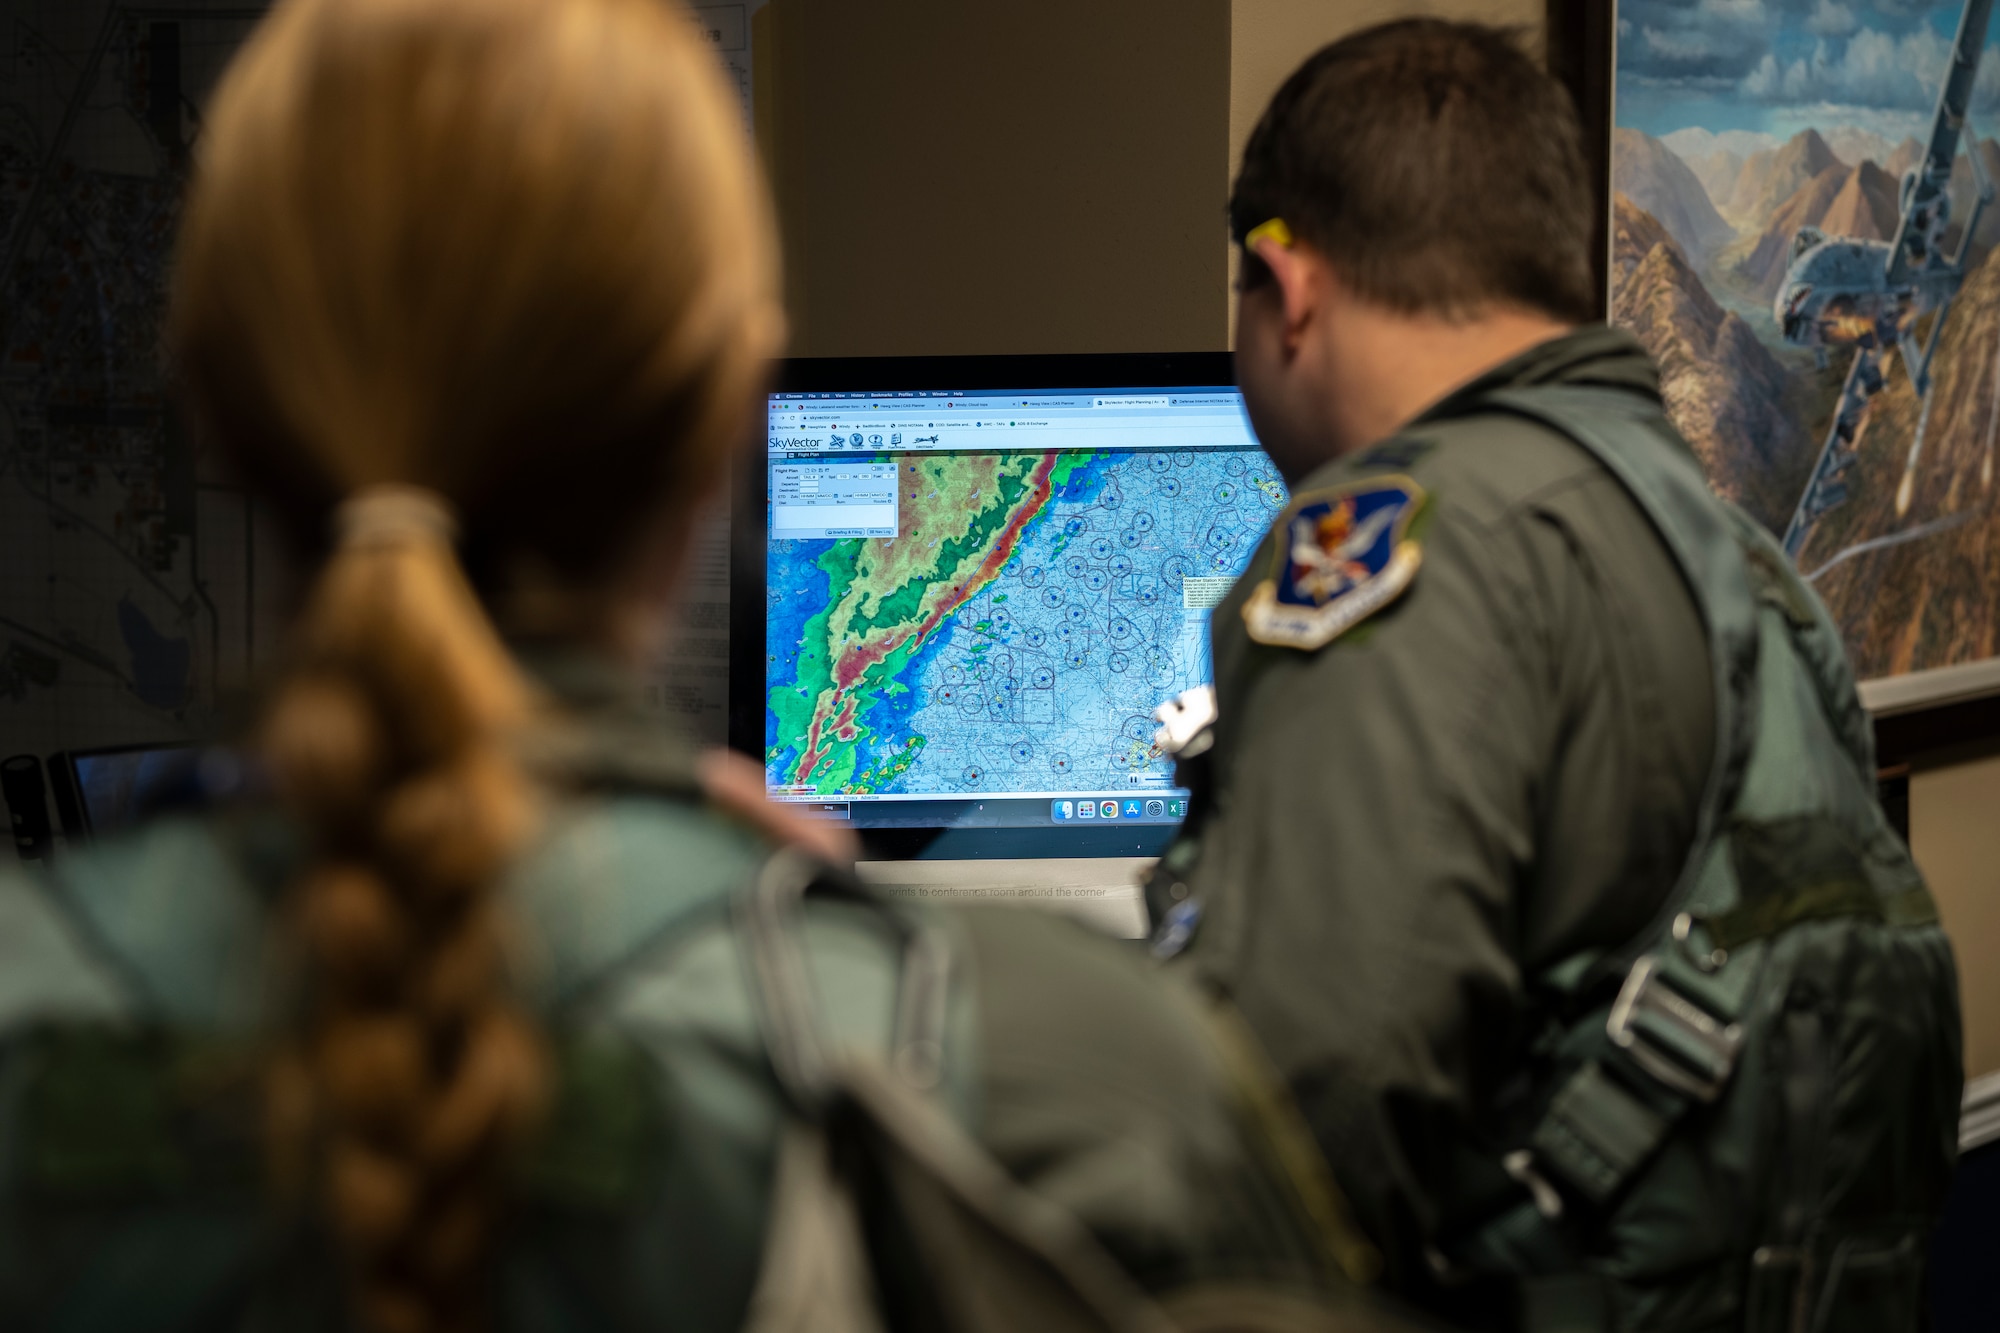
left=728, top=352, right=1236, bottom=861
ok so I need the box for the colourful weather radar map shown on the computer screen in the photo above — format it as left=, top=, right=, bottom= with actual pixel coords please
left=766, top=416, right=1286, bottom=797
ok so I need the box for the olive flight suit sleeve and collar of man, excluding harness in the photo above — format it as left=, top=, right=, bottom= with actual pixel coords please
left=1148, top=328, right=1714, bottom=1287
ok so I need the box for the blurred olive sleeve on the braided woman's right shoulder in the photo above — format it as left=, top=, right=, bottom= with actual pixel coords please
left=944, top=907, right=1332, bottom=1291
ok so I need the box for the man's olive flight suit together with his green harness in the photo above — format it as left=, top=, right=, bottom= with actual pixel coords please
left=1150, top=330, right=1960, bottom=1333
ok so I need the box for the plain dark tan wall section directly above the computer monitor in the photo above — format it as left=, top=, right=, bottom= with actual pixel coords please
left=756, top=0, right=1230, bottom=356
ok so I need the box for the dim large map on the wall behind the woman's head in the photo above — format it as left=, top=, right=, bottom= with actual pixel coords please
left=0, top=0, right=762, bottom=788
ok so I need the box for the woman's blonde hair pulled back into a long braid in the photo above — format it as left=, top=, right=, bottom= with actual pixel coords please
left=170, top=0, right=782, bottom=1333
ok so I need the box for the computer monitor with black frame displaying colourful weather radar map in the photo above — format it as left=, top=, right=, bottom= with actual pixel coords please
left=730, top=354, right=1286, bottom=859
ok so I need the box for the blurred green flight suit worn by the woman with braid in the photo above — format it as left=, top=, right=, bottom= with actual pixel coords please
left=0, top=656, right=1400, bottom=1333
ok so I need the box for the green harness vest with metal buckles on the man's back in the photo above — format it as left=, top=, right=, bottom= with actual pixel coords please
left=1446, top=386, right=1962, bottom=1333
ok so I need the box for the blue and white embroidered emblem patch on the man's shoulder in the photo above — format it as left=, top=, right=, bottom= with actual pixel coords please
left=1244, top=476, right=1424, bottom=648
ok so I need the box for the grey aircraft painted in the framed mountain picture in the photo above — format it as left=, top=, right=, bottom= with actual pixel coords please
left=1772, top=0, right=1994, bottom=560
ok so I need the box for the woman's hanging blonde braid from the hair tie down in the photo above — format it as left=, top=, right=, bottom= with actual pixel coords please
left=262, top=488, right=548, bottom=1333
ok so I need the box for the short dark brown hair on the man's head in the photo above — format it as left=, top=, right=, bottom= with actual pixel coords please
left=1230, top=18, right=1596, bottom=322
